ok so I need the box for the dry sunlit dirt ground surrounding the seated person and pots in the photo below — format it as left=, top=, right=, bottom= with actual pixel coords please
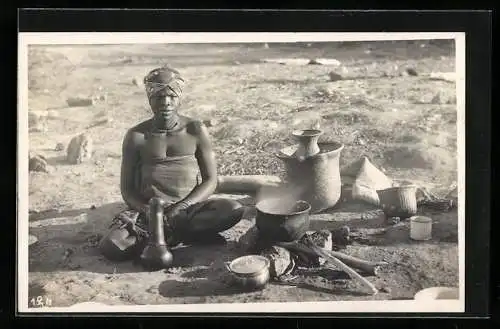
left=25, top=41, right=458, bottom=306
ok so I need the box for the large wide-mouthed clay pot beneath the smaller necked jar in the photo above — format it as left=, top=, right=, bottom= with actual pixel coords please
left=277, top=143, right=344, bottom=213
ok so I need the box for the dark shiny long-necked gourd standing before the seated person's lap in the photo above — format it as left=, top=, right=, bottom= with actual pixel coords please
left=141, top=198, right=173, bottom=270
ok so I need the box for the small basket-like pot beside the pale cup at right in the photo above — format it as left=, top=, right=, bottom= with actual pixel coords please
left=377, top=185, right=417, bottom=219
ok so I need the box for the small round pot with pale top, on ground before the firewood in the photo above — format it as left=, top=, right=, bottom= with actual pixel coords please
left=224, top=255, right=271, bottom=290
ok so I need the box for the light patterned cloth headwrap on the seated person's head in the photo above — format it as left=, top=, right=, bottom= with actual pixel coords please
left=144, top=66, right=185, bottom=98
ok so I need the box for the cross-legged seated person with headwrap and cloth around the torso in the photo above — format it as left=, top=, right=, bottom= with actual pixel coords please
left=100, top=67, right=244, bottom=260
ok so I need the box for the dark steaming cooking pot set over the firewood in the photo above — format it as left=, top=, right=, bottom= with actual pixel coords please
left=255, top=199, right=311, bottom=242
